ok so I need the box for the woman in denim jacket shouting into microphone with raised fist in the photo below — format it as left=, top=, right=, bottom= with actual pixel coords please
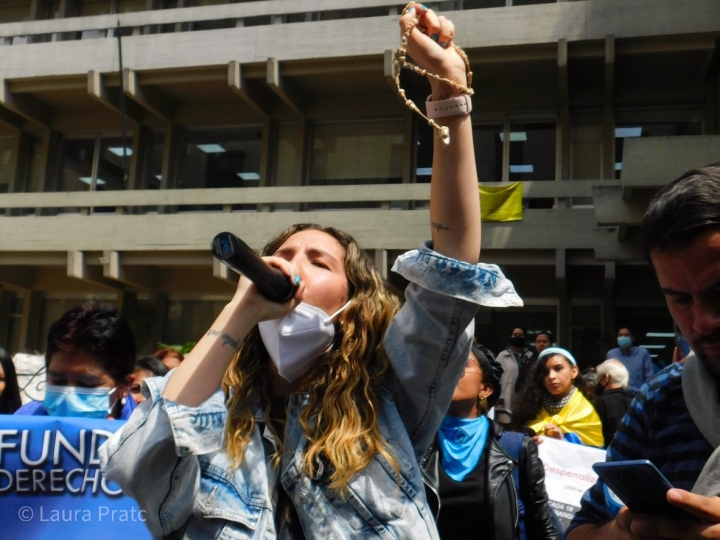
left=100, top=4, right=521, bottom=540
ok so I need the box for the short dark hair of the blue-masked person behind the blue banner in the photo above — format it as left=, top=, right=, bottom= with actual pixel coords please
left=45, top=302, right=135, bottom=382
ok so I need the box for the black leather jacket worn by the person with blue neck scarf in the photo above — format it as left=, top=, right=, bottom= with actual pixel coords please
left=422, top=421, right=560, bottom=540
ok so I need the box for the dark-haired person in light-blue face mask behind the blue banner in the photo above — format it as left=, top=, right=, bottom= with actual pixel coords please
left=15, top=303, right=135, bottom=420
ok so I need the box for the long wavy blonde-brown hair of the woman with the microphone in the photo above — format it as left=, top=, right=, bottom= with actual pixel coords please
left=223, top=223, right=399, bottom=492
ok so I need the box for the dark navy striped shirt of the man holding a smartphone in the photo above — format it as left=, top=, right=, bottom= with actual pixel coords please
left=565, top=364, right=714, bottom=536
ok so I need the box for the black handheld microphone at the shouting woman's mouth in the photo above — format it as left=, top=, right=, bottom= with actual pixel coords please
left=210, top=232, right=297, bottom=304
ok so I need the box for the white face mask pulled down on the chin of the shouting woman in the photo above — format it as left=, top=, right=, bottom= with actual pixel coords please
left=258, top=301, right=350, bottom=382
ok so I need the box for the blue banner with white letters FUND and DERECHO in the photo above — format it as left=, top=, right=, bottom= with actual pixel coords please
left=0, top=415, right=150, bottom=540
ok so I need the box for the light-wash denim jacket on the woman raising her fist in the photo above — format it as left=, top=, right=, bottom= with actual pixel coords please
left=100, top=246, right=522, bottom=540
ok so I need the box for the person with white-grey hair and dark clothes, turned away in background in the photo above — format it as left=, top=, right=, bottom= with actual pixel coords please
left=595, top=358, right=635, bottom=448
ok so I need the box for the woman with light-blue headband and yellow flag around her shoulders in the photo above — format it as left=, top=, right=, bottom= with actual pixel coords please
left=513, top=347, right=603, bottom=447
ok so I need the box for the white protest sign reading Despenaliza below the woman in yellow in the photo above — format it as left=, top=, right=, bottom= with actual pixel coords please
left=538, top=437, right=605, bottom=529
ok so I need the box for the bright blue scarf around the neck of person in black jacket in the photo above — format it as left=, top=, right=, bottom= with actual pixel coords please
left=438, top=415, right=490, bottom=482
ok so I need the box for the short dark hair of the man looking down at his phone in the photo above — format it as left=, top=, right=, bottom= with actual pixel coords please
left=640, top=163, right=720, bottom=262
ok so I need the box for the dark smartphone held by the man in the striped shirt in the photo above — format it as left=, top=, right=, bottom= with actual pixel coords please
left=593, top=459, right=698, bottom=519
